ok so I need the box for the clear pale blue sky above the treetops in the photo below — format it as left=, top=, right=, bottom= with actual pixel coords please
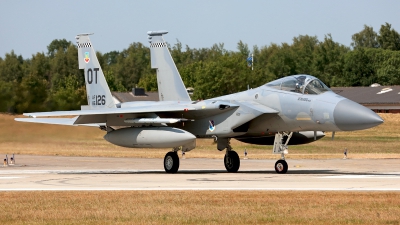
left=0, top=0, right=400, bottom=58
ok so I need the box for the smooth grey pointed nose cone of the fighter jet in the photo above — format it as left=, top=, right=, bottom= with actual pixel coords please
left=333, top=99, right=383, bottom=131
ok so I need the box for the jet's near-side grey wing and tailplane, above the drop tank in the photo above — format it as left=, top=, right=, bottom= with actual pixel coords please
left=16, top=101, right=239, bottom=126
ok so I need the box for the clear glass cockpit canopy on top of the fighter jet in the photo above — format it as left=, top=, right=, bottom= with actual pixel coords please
left=265, top=74, right=331, bottom=95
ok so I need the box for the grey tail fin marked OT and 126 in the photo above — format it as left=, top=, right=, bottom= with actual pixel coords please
left=76, top=34, right=116, bottom=109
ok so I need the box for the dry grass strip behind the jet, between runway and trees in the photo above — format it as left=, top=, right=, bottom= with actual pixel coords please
left=0, top=114, right=400, bottom=159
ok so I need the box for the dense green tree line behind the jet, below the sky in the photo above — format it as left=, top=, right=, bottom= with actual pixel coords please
left=0, top=23, right=400, bottom=113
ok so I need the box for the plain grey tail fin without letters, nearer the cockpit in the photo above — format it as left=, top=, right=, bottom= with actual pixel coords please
left=147, top=31, right=191, bottom=101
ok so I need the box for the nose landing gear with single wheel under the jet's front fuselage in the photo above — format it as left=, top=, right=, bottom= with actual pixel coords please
left=273, top=132, right=293, bottom=173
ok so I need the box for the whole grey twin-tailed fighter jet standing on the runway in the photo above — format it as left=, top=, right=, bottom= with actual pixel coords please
left=15, top=31, right=383, bottom=173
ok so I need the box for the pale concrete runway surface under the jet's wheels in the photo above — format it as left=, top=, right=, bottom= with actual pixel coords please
left=0, top=155, right=400, bottom=191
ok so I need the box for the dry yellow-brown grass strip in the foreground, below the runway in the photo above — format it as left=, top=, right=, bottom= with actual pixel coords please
left=0, top=191, right=400, bottom=224
